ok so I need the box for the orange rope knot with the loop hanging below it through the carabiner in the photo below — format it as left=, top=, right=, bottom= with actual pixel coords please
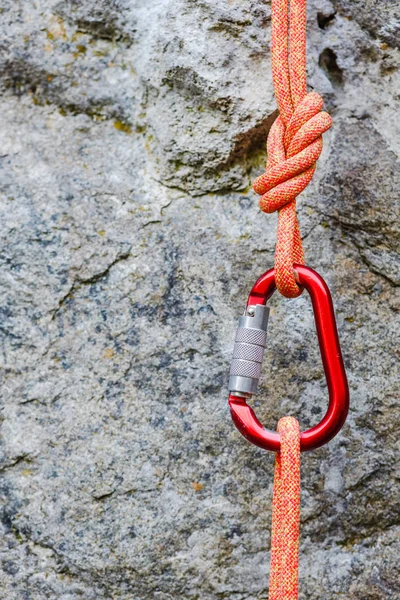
left=253, top=92, right=332, bottom=298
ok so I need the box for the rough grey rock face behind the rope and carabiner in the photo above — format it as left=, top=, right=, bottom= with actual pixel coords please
left=0, top=0, right=400, bottom=600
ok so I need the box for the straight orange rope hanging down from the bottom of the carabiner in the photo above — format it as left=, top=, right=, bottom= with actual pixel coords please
left=269, top=417, right=300, bottom=600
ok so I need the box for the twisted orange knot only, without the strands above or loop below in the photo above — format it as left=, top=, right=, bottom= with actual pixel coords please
left=253, top=92, right=332, bottom=213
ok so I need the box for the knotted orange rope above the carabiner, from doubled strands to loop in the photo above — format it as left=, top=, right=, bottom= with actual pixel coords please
left=253, top=0, right=332, bottom=298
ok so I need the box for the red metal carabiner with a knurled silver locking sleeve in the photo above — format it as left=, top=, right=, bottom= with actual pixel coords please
left=229, top=265, right=349, bottom=452
